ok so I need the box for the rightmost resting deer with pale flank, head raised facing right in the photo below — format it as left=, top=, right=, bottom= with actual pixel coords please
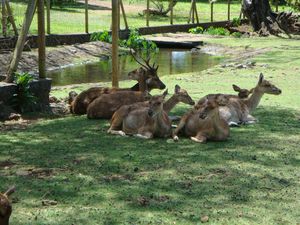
left=195, top=73, right=282, bottom=126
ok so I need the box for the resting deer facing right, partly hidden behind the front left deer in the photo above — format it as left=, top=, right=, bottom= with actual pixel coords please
left=107, top=84, right=195, bottom=134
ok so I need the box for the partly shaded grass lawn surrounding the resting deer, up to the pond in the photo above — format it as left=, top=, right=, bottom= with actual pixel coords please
left=0, top=38, right=300, bottom=225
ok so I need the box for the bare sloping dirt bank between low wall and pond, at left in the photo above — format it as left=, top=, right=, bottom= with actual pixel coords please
left=0, top=41, right=111, bottom=76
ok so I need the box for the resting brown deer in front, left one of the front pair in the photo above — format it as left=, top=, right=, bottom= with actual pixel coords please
left=108, top=92, right=172, bottom=139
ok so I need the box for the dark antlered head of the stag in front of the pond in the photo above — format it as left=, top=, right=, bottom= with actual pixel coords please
left=128, top=52, right=166, bottom=90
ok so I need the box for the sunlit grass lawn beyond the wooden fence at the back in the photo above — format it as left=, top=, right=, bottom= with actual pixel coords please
left=5, top=0, right=290, bottom=34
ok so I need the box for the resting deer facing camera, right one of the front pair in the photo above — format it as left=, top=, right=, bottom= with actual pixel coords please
left=173, top=100, right=229, bottom=143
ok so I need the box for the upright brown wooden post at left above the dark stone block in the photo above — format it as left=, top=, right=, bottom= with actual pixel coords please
left=38, top=0, right=46, bottom=78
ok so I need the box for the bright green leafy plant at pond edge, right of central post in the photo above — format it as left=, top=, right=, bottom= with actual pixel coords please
left=121, top=30, right=158, bottom=52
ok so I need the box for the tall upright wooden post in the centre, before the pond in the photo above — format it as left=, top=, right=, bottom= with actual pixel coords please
left=111, top=0, right=120, bottom=87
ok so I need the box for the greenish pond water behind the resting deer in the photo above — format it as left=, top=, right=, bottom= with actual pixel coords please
left=47, top=49, right=219, bottom=86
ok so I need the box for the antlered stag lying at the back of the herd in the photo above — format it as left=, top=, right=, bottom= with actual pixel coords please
left=69, top=54, right=166, bottom=115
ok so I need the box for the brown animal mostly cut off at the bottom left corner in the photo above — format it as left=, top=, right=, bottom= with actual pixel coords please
left=0, top=187, right=15, bottom=225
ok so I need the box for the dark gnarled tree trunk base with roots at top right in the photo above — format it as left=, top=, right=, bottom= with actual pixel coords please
left=242, top=0, right=300, bottom=36
